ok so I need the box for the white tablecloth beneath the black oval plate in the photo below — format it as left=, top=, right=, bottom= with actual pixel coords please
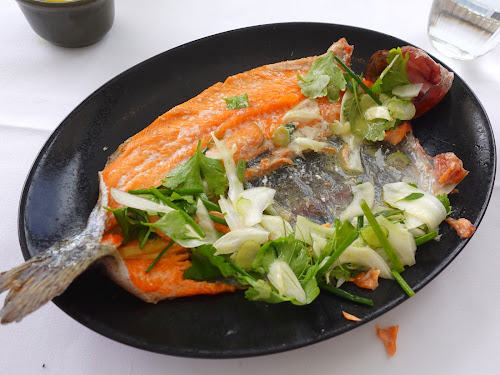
left=0, top=0, right=500, bottom=375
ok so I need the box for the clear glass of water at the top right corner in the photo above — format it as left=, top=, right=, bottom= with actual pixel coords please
left=427, top=0, right=500, bottom=60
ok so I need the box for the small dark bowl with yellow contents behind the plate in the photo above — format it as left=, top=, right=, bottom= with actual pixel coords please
left=16, top=0, right=115, bottom=47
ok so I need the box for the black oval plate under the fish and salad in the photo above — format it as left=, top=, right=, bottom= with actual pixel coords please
left=19, top=23, right=496, bottom=358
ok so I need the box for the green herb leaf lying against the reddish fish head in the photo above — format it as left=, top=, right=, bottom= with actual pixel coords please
left=370, top=47, right=411, bottom=94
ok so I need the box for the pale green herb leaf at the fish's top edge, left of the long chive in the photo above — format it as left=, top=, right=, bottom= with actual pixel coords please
left=297, top=51, right=346, bottom=102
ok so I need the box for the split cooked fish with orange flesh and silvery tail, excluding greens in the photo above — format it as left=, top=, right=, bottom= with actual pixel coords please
left=0, top=38, right=463, bottom=323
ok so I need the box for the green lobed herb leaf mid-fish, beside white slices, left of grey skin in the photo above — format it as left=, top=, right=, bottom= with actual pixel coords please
left=163, top=141, right=228, bottom=195
